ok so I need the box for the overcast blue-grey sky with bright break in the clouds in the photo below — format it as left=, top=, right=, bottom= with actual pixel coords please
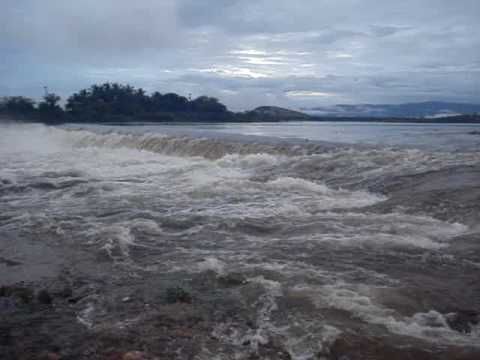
left=0, top=0, right=480, bottom=110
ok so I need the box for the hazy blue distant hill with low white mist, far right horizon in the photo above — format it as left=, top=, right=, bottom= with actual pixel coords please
left=302, top=101, right=480, bottom=118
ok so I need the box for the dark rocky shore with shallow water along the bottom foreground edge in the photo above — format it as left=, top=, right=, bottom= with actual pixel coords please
left=0, top=264, right=480, bottom=360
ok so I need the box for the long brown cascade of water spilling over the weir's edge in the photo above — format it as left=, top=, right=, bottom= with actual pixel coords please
left=52, top=128, right=480, bottom=177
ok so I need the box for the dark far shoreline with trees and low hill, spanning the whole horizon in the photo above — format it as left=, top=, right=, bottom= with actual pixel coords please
left=0, top=83, right=480, bottom=124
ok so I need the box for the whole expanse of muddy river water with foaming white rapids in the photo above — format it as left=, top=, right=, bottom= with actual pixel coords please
left=0, top=123, right=480, bottom=359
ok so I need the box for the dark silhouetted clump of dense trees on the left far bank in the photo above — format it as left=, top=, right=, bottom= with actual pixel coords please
left=0, top=83, right=233, bottom=123
